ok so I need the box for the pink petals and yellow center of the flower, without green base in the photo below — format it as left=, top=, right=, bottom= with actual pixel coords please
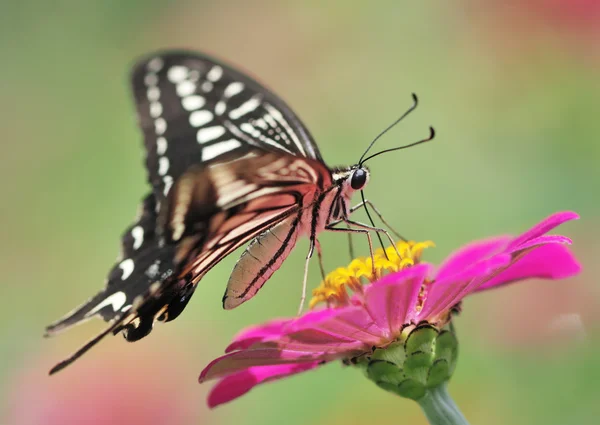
left=200, top=212, right=581, bottom=407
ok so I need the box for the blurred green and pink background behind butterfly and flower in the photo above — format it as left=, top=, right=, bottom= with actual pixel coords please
left=0, top=0, right=600, bottom=425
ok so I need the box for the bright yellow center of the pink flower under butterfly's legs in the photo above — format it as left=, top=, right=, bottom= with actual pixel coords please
left=310, top=241, right=435, bottom=308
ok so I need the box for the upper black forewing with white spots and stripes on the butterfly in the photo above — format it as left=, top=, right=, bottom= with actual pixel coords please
left=132, top=52, right=323, bottom=199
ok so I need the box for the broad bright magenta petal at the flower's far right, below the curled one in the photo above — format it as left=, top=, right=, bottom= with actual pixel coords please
left=477, top=244, right=581, bottom=291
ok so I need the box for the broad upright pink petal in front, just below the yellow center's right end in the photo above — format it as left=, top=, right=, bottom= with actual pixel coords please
left=365, top=264, right=432, bottom=332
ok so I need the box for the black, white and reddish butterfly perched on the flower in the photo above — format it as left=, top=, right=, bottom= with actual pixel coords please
left=46, top=51, right=434, bottom=374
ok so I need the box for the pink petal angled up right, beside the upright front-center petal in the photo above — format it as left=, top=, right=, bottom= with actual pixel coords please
left=417, top=254, right=511, bottom=320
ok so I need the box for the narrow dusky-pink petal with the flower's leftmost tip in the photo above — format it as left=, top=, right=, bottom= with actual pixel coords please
left=199, top=348, right=354, bottom=382
